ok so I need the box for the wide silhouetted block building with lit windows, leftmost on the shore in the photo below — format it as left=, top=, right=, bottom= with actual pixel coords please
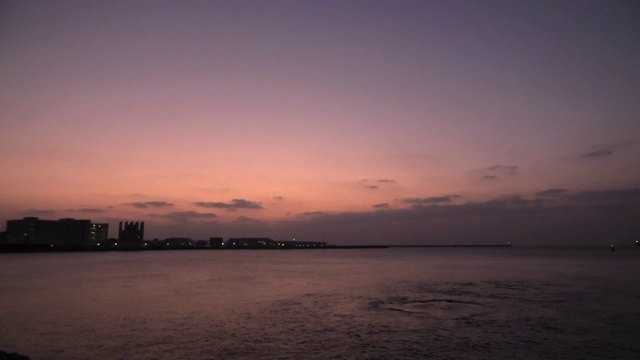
left=5, top=217, right=109, bottom=248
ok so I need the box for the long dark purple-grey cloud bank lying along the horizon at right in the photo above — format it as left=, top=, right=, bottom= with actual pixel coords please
left=275, top=189, right=640, bottom=248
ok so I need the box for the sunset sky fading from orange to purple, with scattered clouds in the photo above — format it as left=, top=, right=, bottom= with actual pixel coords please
left=0, top=0, right=640, bottom=245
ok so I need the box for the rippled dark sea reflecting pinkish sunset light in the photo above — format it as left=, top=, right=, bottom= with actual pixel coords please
left=0, top=248, right=640, bottom=360
